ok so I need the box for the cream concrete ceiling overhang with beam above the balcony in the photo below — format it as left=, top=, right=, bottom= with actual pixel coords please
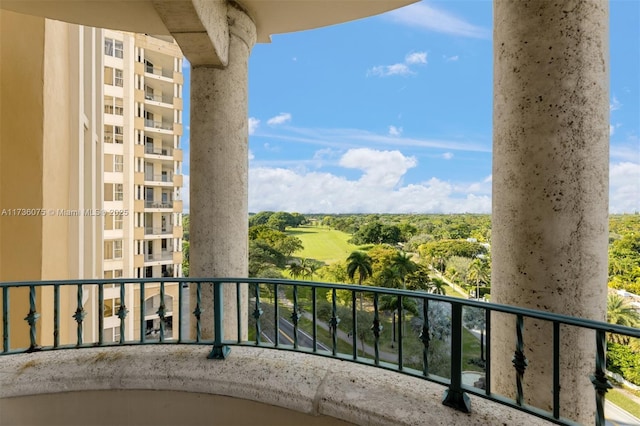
left=0, top=0, right=418, bottom=66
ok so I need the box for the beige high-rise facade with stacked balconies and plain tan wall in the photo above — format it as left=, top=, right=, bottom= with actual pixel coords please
left=0, top=11, right=184, bottom=347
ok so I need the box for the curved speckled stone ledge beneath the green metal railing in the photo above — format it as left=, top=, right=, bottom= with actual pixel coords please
left=0, top=345, right=550, bottom=425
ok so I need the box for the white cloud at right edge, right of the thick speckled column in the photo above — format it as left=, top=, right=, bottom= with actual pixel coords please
left=609, top=162, right=640, bottom=213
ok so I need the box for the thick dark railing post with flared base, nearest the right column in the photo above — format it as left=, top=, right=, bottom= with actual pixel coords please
left=442, top=303, right=471, bottom=413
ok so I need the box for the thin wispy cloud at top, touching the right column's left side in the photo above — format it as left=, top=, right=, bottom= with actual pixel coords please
left=386, top=2, right=491, bottom=39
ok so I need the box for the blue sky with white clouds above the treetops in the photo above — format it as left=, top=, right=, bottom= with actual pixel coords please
left=181, top=0, right=640, bottom=213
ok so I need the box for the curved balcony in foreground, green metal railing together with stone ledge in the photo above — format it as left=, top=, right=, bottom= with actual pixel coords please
left=0, top=278, right=640, bottom=425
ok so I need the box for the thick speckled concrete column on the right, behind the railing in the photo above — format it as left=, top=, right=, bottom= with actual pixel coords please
left=491, top=0, right=609, bottom=424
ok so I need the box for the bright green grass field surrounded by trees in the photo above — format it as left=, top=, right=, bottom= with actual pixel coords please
left=287, top=226, right=358, bottom=264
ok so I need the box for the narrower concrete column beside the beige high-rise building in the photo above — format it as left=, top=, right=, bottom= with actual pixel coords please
left=190, top=4, right=256, bottom=339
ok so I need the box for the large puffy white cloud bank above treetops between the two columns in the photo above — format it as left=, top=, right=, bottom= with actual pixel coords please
left=249, top=148, right=491, bottom=213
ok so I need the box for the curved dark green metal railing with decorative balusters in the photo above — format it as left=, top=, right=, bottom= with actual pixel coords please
left=0, top=278, right=640, bottom=425
